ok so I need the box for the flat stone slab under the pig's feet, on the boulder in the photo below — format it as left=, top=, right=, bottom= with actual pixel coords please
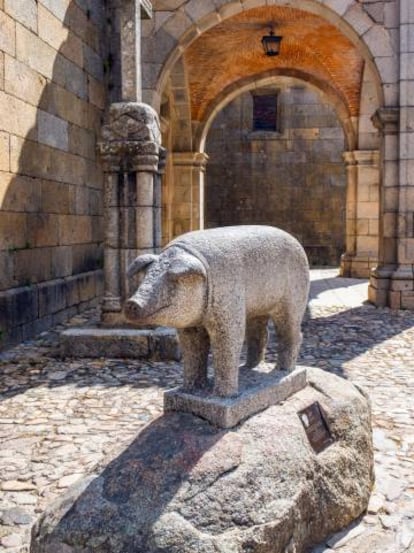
left=164, top=365, right=306, bottom=428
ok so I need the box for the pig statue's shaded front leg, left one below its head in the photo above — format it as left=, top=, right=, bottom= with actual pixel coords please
left=178, top=327, right=210, bottom=390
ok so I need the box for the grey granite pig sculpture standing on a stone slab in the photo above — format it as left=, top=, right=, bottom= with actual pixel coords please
left=124, top=226, right=309, bottom=397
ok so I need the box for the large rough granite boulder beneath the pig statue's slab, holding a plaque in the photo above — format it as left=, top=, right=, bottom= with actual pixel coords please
left=31, top=369, right=373, bottom=553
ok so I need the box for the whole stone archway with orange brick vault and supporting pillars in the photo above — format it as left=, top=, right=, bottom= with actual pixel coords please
left=117, top=0, right=414, bottom=308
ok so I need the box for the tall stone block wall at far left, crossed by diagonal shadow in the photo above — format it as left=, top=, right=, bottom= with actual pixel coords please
left=0, top=0, right=106, bottom=347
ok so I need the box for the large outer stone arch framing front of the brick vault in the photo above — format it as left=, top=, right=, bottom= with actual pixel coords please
left=143, top=0, right=388, bottom=109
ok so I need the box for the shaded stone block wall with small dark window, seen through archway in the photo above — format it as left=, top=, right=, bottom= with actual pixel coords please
left=206, top=86, right=346, bottom=265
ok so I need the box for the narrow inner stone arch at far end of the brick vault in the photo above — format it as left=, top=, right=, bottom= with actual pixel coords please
left=194, top=69, right=357, bottom=152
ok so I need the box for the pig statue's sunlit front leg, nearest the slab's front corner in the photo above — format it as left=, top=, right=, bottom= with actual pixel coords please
left=208, top=313, right=246, bottom=397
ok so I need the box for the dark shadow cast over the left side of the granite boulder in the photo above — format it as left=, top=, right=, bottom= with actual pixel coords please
left=31, top=413, right=227, bottom=553
